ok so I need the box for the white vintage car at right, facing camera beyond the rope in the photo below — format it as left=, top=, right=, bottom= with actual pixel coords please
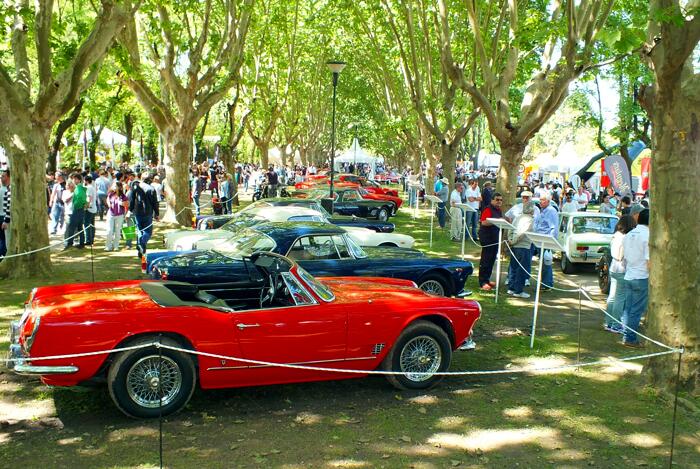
left=559, top=212, right=617, bottom=274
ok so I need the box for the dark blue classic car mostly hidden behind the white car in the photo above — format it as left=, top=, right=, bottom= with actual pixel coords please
left=194, top=197, right=395, bottom=233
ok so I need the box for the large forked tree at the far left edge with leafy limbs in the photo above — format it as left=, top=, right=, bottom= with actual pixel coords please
left=0, top=0, right=138, bottom=278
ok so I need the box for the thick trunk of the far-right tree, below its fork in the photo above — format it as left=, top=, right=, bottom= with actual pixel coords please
left=646, top=79, right=700, bottom=395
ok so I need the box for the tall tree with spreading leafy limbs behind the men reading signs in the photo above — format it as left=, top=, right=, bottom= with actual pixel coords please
left=439, top=0, right=614, bottom=204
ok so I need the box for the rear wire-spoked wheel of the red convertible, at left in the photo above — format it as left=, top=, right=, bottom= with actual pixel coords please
left=107, top=337, right=197, bottom=418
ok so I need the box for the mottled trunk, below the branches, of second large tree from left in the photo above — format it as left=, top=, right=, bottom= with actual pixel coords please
left=163, top=127, right=194, bottom=226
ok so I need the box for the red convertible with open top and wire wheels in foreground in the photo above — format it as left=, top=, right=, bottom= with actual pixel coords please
left=9, top=253, right=481, bottom=418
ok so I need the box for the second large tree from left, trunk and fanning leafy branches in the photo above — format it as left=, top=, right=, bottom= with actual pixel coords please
left=120, top=0, right=254, bottom=226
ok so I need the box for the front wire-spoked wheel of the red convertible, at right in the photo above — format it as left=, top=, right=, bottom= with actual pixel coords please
left=381, top=321, right=452, bottom=389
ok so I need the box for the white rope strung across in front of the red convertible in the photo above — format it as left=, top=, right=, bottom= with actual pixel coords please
left=0, top=342, right=684, bottom=376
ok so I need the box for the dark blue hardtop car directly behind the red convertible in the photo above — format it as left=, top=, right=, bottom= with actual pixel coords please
left=150, top=222, right=473, bottom=296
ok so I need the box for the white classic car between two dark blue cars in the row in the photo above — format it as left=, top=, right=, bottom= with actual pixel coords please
left=165, top=206, right=416, bottom=251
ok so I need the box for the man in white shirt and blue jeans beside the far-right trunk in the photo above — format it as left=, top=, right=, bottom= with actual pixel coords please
left=622, top=209, right=649, bottom=348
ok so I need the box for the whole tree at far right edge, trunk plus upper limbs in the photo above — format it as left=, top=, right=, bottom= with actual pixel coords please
left=640, top=0, right=700, bottom=394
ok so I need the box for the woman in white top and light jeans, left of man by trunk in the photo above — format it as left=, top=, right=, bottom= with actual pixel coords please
left=604, top=215, right=636, bottom=334
